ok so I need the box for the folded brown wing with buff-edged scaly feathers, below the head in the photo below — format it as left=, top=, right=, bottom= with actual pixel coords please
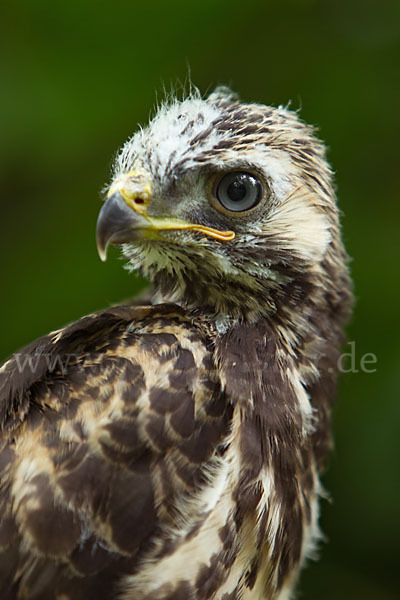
left=0, top=306, right=232, bottom=600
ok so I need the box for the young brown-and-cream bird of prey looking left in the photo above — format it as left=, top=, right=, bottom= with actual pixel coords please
left=0, top=88, right=351, bottom=600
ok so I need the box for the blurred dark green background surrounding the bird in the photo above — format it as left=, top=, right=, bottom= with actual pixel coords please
left=0, top=0, right=400, bottom=600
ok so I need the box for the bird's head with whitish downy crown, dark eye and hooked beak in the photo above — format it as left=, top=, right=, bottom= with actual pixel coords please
left=97, top=88, right=346, bottom=318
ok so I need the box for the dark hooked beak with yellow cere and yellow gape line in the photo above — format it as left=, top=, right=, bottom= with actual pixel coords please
left=96, top=170, right=235, bottom=261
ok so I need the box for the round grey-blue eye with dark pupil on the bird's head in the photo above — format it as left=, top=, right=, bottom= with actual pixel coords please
left=216, top=171, right=263, bottom=212
